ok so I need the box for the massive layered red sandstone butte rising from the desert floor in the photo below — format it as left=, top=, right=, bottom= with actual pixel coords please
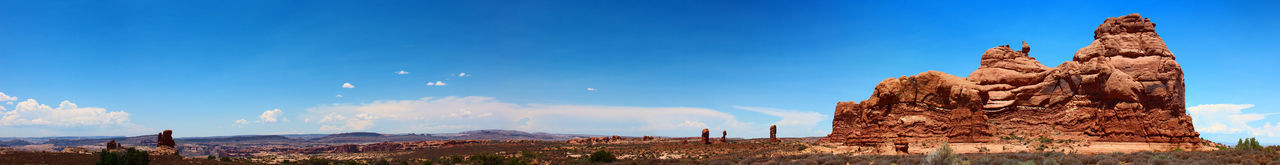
left=822, top=14, right=1201, bottom=146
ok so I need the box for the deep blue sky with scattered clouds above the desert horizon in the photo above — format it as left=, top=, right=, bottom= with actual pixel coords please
left=0, top=0, right=1280, bottom=142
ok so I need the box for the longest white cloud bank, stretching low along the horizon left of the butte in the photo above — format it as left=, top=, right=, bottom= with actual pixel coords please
left=303, top=96, right=826, bottom=137
